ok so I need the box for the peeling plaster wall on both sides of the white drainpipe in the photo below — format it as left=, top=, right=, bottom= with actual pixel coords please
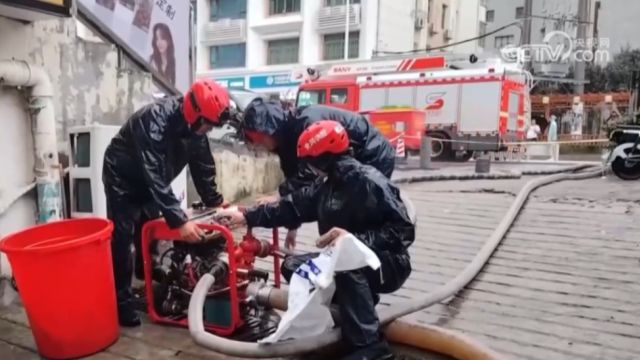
left=0, top=16, right=155, bottom=236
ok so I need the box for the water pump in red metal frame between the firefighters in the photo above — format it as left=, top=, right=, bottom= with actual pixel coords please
left=142, top=208, right=283, bottom=341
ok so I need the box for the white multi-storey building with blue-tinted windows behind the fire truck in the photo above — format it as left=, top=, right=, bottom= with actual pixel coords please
left=197, top=0, right=484, bottom=97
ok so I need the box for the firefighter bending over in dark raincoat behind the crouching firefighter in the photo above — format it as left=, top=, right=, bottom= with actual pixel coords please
left=242, top=98, right=395, bottom=248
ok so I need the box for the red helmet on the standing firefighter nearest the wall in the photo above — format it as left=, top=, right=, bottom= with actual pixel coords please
left=183, top=79, right=230, bottom=125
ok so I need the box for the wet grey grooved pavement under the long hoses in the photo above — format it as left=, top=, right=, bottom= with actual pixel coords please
left=0, top=164, right=640, bottom=360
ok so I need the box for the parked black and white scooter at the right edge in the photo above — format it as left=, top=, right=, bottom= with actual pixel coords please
left=606, top=125, right=640, bottom=180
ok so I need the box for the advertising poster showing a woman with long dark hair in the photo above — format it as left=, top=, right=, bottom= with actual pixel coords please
left=78, top=0, right=191, bottom=92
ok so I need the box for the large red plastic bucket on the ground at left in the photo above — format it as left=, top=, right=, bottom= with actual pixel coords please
left=0, top=218, right=119, bottom=359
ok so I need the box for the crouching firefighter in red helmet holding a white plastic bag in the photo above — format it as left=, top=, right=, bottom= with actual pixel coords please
left=219, top=120, right=415, bottom=360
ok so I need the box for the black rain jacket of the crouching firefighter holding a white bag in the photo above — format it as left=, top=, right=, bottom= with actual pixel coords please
left=245, top=156, right=415, bottom=255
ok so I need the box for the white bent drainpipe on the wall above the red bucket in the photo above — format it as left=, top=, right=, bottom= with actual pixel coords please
left=0, top=60, right=62, bottom=223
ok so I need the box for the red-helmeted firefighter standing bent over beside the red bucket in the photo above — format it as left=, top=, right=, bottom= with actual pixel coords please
left=102, top=80, right=230, bottom=326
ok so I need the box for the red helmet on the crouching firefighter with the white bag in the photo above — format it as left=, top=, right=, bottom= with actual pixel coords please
left=298, top=120, right=349, bottom=157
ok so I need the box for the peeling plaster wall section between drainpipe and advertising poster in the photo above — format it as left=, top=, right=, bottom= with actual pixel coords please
left=28, top=19, right=157, bottom=152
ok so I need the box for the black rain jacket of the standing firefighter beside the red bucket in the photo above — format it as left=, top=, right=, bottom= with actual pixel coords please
left=102, top=97, right=223, bottom=228
